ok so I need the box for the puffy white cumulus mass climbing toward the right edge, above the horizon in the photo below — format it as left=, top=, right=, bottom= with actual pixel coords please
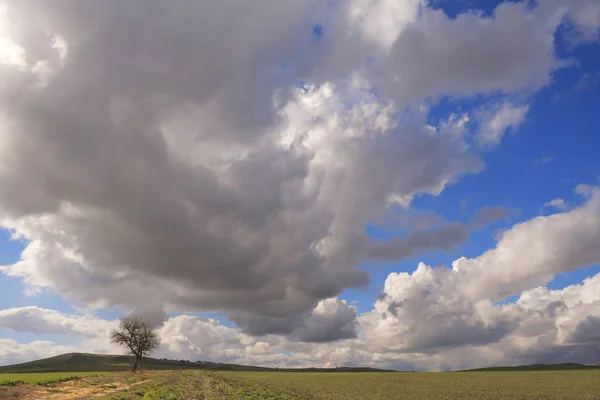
left=360, top=189, right=600, bottom=360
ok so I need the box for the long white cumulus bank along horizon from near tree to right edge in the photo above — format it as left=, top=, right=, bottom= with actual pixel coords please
left=155, top=188, right=600, bottom=370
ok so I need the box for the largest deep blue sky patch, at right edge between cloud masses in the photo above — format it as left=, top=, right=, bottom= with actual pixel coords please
left=414, top=55, right=600, bottom=225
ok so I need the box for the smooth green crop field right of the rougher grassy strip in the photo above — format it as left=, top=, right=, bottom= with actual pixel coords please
left=220, top=370, right=600, bottom=400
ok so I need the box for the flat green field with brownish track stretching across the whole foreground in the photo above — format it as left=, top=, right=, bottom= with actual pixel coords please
left=0, top=370, right=600, bottom=400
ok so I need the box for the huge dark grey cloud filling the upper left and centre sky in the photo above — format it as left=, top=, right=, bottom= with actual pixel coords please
left=0, top=1, right=481, bottom=341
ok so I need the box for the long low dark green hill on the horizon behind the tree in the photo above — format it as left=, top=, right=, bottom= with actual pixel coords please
left=0, top=353, right=394, bottom=373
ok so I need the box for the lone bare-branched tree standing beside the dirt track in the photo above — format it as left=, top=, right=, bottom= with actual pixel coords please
left=110, top=316, right=160, bottom=374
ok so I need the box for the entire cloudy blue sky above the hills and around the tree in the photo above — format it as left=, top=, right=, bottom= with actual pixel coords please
left=0, top=0, right=600, bottom=371
